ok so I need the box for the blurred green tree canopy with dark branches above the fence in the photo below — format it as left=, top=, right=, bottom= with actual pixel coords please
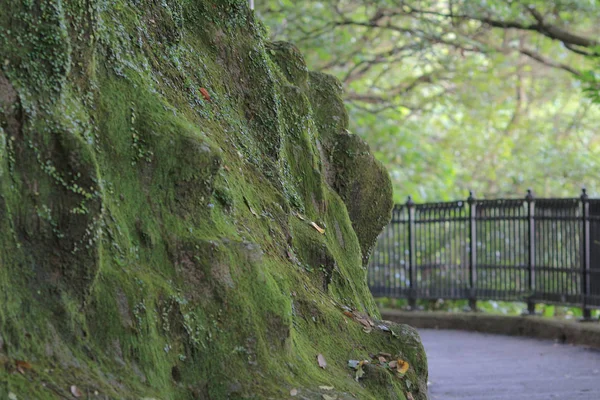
left=257, top=0, right=600, bottom=201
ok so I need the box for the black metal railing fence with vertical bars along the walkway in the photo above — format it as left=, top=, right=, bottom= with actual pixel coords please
left=368, top=189, right=600, bottom=317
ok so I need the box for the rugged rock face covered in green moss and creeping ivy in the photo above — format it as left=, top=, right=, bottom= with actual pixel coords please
left=0, top=0, right=427, bottom=399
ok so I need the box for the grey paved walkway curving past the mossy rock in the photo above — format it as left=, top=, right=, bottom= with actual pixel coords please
left=419, top=329, right=600, bottom=400
